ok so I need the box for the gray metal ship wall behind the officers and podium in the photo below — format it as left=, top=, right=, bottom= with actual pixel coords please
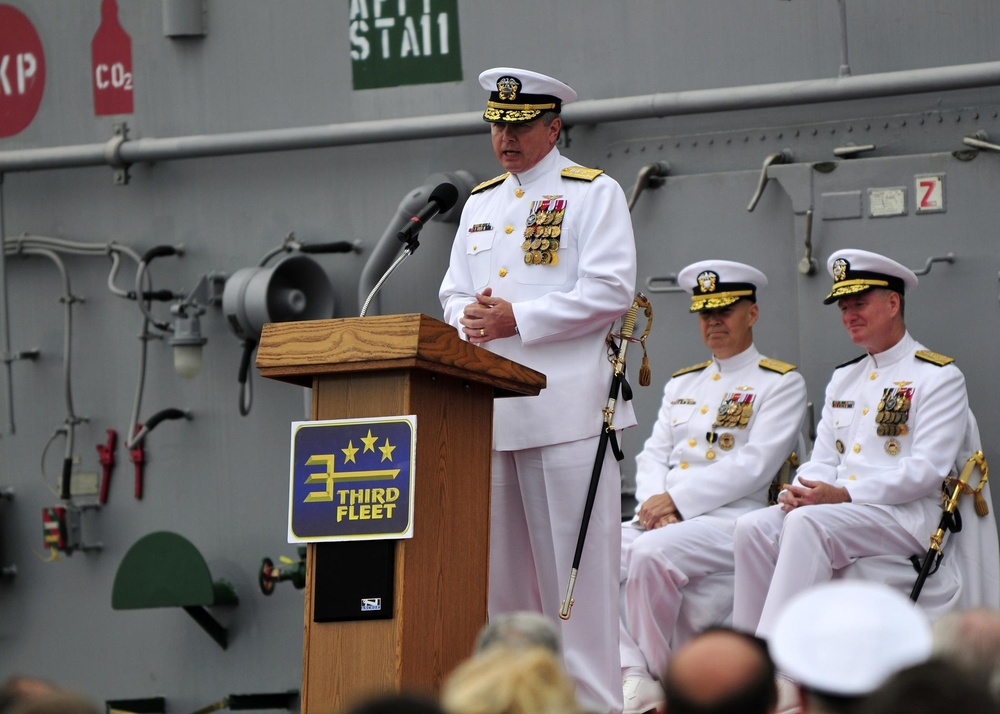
left=0, top=0, right=1000, bottom=711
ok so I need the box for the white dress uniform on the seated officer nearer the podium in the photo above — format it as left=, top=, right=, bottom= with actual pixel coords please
left=621, top=345, right=806, bottom=679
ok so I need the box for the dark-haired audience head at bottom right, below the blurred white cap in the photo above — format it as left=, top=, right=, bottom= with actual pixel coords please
left=858, top=658, right=998, bottom=714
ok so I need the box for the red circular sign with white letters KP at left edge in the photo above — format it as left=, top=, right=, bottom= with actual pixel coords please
left=0, top=5, right=45, bottom=137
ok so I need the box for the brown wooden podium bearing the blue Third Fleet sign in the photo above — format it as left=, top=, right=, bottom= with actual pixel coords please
left=257, top=314, right=545, bottom=714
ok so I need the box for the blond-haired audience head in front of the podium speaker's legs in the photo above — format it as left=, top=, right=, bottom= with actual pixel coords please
left=441, top=645, right=580, bottom=714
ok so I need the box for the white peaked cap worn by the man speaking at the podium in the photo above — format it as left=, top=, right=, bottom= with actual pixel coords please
left=479, top=67, right=576, bottom=124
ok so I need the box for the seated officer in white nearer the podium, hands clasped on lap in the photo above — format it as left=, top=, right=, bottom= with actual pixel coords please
left=621, top=260, right=806, bottom=714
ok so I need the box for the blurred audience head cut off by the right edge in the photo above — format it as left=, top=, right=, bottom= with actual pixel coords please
left=932, top=607, right=1000, bottom=701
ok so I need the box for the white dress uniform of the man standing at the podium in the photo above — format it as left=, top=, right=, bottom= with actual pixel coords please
left=440, top=148, right=636, bottom=712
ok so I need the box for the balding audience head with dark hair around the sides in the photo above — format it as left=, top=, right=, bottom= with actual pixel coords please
left=663, top=628, right=777, bottom=714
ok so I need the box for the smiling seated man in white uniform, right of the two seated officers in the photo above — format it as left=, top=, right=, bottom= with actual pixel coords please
left=733, top=250, right=969, bottom=637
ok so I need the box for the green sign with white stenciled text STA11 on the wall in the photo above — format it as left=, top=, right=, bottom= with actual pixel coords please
left=350, top=0, right=462, bottom=89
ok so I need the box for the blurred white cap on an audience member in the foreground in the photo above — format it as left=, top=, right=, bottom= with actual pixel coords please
left=768, top=580, right=931, bottom=697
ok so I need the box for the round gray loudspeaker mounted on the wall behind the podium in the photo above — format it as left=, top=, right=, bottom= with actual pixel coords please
left=222, top=253, right=333, bottom=340
